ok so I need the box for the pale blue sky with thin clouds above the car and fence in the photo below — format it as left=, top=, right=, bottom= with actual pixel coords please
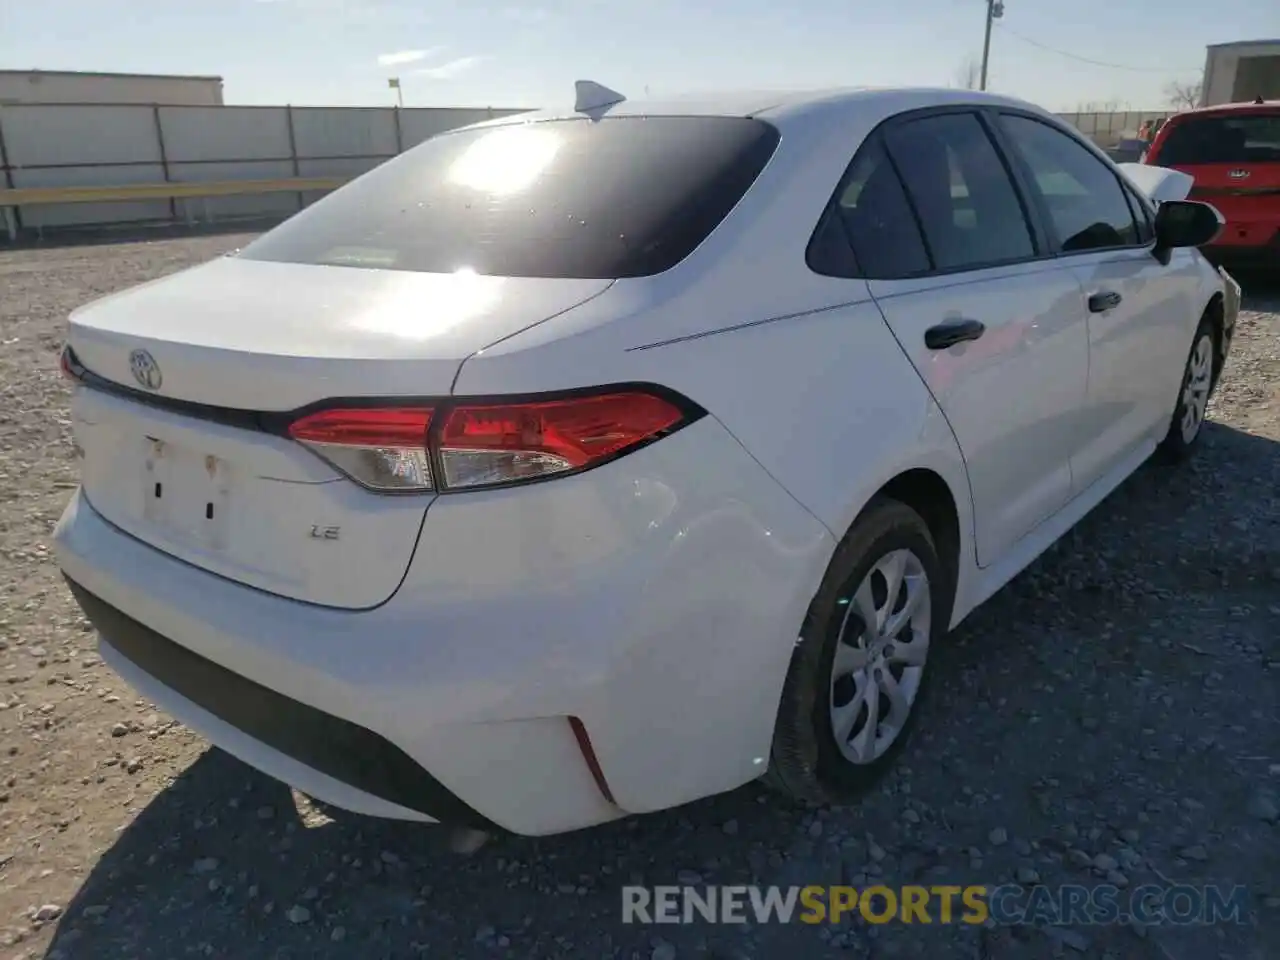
left=0, top=0, right=1280, bottom=110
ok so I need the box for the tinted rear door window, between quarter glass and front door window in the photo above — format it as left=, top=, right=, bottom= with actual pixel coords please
left=886, top=114, right=1036, bottom=270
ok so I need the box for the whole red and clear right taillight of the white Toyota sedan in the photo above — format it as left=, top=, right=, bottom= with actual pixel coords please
left=288, top=388, right=701, bottom=493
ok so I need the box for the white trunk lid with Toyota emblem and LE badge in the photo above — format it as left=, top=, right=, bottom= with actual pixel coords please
left=68, top=257, right=609, bottom=609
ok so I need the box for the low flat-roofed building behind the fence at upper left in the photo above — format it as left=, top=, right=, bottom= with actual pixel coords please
left=0, top=70, right=223, bottom=106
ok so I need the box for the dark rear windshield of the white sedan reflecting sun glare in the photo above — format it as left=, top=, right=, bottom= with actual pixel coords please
left=239, top=116, right=778, bottom=279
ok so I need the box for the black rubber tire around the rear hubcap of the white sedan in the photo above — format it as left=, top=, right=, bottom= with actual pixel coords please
left=762, top=497, right=954, bottom=804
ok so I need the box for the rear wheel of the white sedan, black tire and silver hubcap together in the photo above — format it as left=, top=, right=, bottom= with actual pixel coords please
left=762, top=497, right=952, bottom=804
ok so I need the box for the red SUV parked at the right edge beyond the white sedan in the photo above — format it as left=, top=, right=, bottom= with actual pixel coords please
left=1143, top=101, right=1280, bottom=270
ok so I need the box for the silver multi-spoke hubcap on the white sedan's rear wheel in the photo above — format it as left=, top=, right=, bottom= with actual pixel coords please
left=831, top=549, right=933, bottom=764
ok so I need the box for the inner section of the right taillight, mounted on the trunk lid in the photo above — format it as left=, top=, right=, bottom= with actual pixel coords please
left=289, top=407, right=433, bottom=493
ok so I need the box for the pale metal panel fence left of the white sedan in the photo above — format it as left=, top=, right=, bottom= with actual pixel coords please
left=0, top=104, right=522, bottom=229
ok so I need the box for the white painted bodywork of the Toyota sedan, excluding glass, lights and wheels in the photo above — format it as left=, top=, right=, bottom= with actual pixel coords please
left=55, top=84, right=1222, bottom=835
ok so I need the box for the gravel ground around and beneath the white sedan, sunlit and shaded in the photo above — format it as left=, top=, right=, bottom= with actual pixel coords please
left=0, top=236, right=1280, bottom=960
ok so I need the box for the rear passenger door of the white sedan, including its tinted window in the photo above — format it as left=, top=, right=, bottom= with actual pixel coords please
left=838, top=110, right=1088, bottom=566
